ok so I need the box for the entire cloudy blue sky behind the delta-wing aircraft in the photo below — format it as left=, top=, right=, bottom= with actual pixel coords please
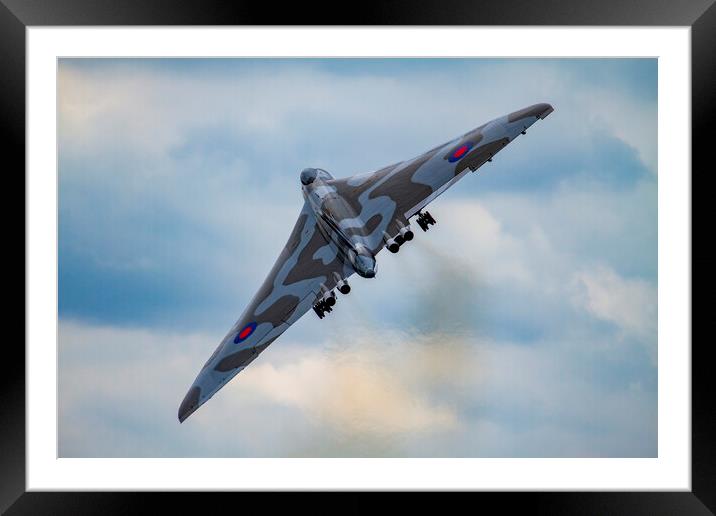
left=58, top=59, right=658, bottom=457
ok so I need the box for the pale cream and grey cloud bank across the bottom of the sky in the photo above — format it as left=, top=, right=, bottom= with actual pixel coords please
left=59, top=321, right=656, bottom=457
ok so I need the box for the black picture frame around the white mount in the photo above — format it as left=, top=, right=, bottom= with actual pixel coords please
left=0, top=0, right=716, bottom=515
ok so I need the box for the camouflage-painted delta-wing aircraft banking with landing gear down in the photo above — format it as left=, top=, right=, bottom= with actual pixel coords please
left=179, top=104, right=553, bottom=422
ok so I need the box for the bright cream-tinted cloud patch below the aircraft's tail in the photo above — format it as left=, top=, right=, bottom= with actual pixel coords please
left=236, top=335, right=457, bottom=436
